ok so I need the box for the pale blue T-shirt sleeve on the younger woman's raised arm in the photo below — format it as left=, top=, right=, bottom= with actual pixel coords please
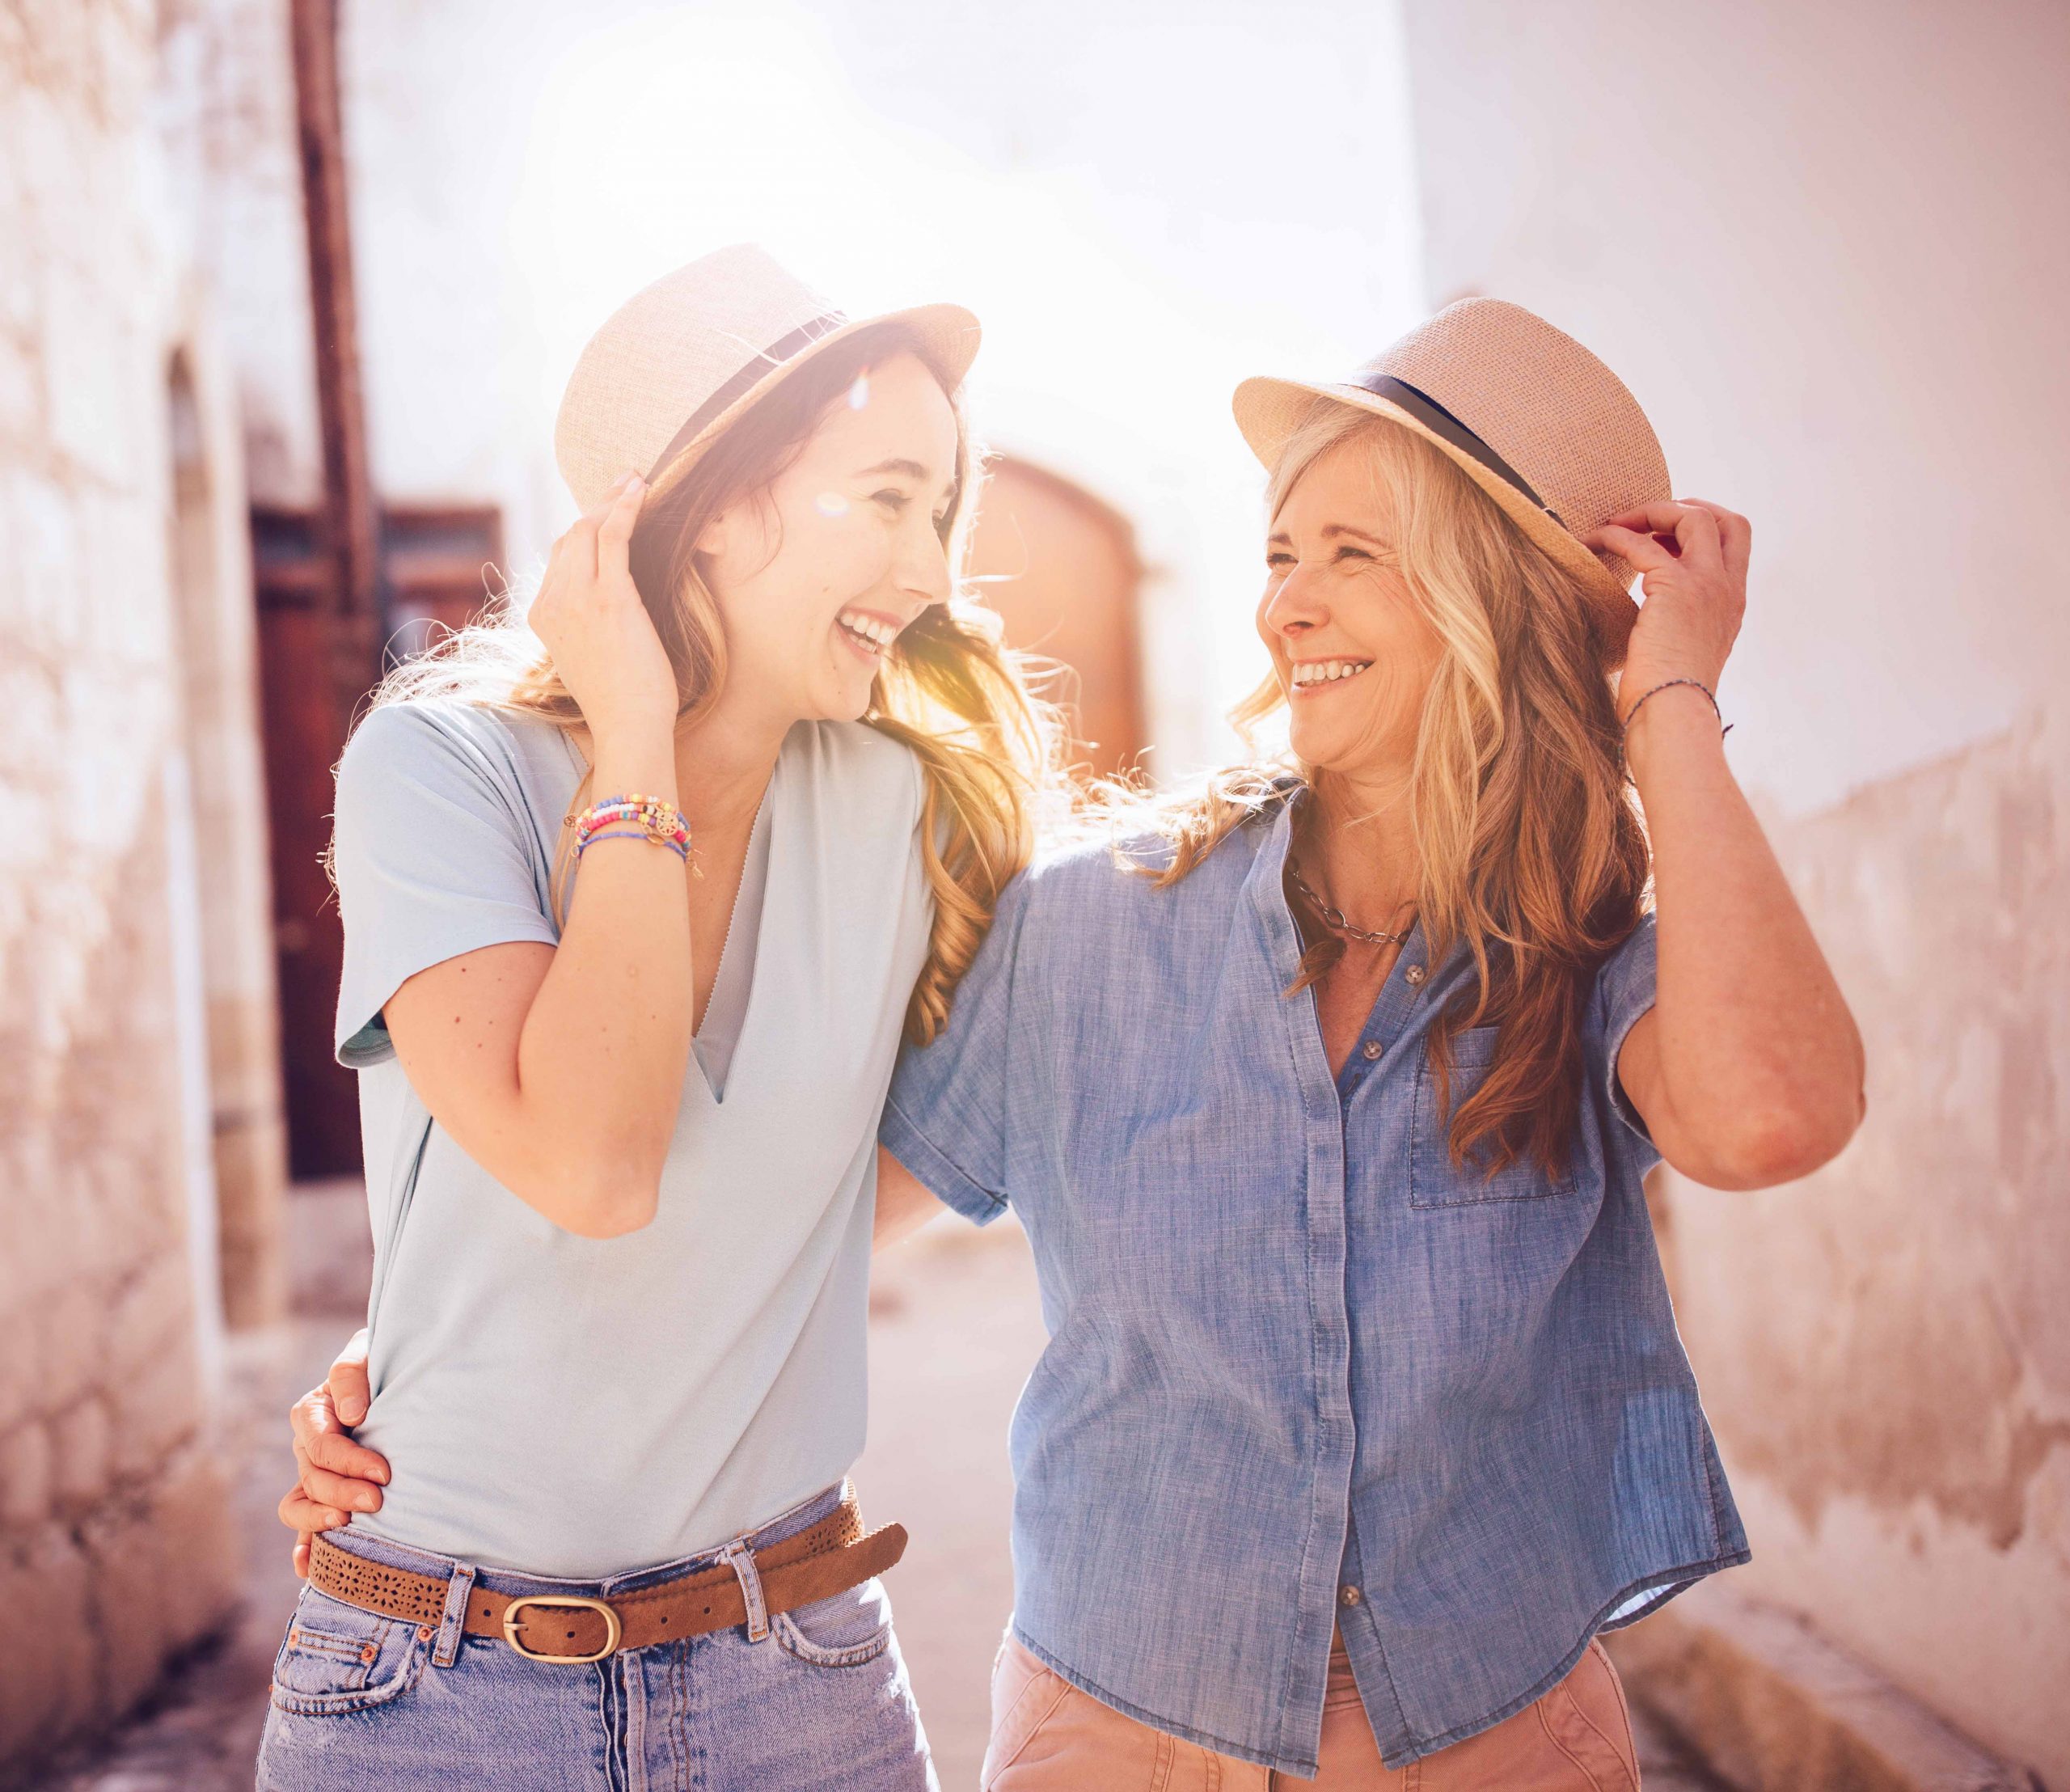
left=333, top=704, right=559, bottom=1070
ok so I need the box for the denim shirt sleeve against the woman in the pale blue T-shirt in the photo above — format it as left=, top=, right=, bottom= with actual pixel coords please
left=877, top=873, right=1031, bottom=1225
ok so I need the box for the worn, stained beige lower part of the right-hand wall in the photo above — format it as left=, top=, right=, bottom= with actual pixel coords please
left=1664, top=712, right=2070, bottom=1786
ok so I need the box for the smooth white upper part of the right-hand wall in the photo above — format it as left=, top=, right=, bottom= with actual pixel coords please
left=1408, top=0, right=2070, bottom=811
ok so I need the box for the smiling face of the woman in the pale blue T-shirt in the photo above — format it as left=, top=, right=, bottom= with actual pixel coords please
left=695, top=354, right=958, bottom=725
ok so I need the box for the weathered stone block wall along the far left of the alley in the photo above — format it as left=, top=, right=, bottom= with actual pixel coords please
left=0, top=0, right=230, bottom=1771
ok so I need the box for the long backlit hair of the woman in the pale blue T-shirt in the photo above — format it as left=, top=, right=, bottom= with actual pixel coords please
left=349, top=323, right=1062, bottom=1045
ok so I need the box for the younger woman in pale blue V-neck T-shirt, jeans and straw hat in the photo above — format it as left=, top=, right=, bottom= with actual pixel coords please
left=259, top=248, right=1046, bottom=1792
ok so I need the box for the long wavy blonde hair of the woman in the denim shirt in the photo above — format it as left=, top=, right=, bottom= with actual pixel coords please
left=1105, top=399, right=1650, bottom=1175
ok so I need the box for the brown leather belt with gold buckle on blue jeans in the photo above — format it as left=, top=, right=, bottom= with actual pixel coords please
left=308, top=1496, right=906, bottom=1663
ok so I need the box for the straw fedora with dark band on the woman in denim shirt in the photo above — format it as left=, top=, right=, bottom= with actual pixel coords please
left=1236, top=298, right=1672, bottom=666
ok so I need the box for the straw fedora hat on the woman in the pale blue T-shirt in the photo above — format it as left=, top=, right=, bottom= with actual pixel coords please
left=553, top=242, right=979, bottom=511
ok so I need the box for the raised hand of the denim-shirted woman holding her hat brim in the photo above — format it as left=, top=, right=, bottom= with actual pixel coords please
left=1582, top=499, right=1753, bottom=716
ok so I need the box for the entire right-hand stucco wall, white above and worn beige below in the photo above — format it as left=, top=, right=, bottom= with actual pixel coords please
left=1408, top=0, right=2070, bottom=1784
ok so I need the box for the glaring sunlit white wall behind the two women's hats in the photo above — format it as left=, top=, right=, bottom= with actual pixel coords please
left=169, top=0, right=1418, bottom=770
